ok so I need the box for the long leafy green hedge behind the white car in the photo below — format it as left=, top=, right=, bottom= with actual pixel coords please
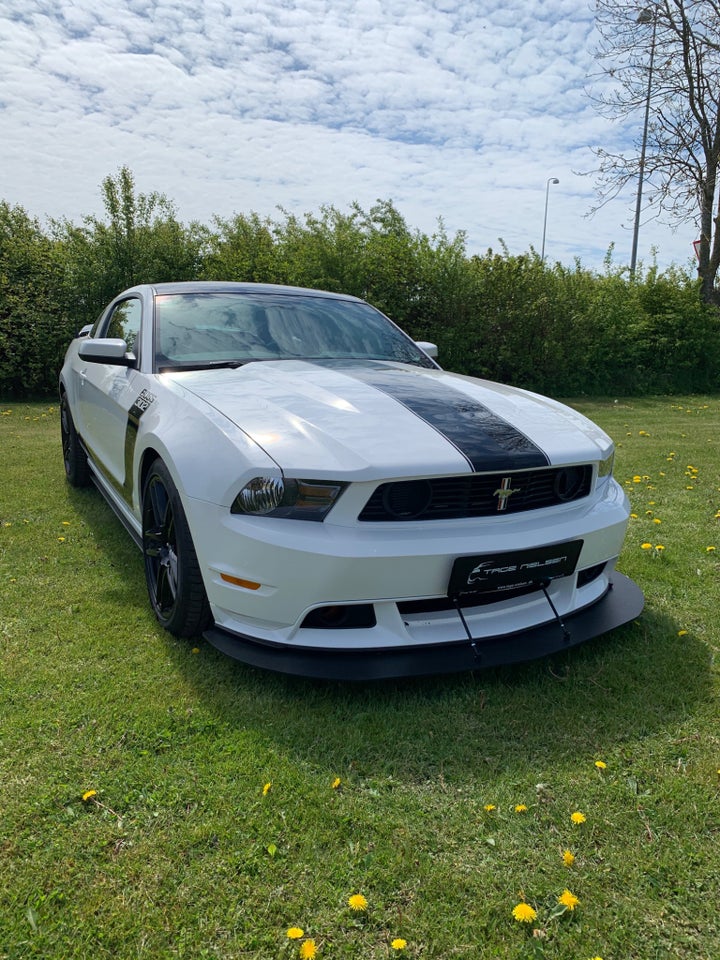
left=0, top=168, right=720, bottom=398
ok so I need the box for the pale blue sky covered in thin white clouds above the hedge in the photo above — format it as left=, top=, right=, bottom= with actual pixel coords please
left=0, top=0, right=695, bottom=268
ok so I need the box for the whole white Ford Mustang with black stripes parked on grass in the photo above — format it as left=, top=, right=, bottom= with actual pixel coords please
left=60, top=283, right=643, bottom=679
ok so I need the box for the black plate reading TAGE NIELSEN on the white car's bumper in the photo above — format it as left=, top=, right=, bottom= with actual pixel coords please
left=448, top=540, right=583, bottom=597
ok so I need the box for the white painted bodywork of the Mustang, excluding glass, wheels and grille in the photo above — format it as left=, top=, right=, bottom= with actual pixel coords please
left=61, top=284, right=642, bottom=676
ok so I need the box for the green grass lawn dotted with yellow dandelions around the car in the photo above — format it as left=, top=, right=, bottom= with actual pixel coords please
left=0, top=397, right=720, bottom=960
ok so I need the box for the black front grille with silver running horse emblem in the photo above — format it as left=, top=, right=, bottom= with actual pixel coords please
left=358, top=463, right=593, bottom=523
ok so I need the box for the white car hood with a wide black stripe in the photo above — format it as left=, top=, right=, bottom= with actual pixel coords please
left=170, top=360, right=612, bottom=479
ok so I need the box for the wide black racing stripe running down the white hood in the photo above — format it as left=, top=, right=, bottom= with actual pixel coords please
left=329, top=362, right=550, bottom=473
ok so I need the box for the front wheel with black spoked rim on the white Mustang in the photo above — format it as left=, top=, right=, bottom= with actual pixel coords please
left=142, top=460, right=212, bottom=637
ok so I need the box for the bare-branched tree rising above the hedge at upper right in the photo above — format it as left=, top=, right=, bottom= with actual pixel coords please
left=596, top=0, right=720, bottom=304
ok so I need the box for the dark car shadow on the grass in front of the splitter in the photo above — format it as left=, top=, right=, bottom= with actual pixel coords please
left=175, top=608, right=711, bottom=779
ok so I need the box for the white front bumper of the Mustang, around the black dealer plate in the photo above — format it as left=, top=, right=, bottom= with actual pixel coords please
left=186, top=482, right=629, bottom=651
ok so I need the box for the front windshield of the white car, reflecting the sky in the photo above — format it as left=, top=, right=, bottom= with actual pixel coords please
left=155, top=293, right=434, bottom=370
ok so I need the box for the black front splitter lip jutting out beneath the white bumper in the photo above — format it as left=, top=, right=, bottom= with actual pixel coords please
left=204, top=572, right=644, bottom=681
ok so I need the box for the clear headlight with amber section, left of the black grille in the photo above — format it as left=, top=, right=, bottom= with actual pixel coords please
left=230, top=477, right=346, bottom=520
